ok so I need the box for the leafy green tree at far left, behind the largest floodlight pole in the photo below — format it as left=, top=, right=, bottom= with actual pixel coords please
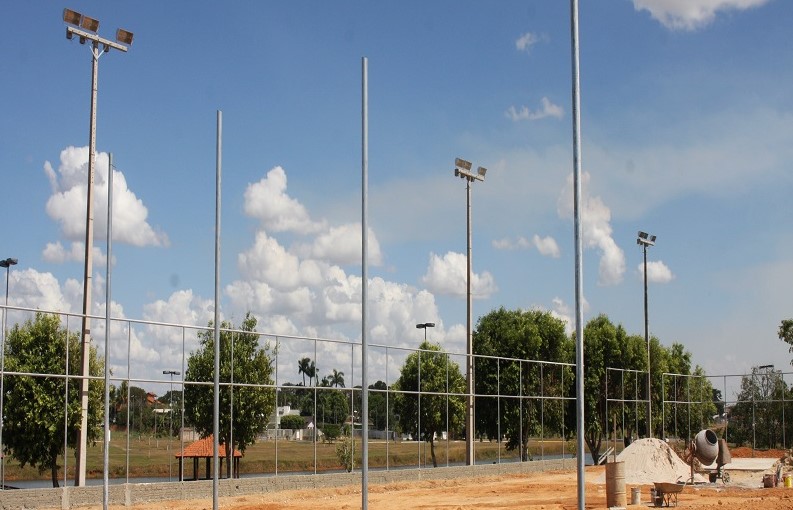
left=3, top=312, right=104, bottom=487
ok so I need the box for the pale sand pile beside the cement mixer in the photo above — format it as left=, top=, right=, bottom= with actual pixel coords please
left=601, top=439, right=705, bottom=484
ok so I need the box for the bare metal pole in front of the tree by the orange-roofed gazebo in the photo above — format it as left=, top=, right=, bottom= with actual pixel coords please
left=212, top=110, right=223, bottom=510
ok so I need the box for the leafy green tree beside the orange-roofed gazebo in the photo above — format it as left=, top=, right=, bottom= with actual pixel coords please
left=184, top=313, right=275, bottom=476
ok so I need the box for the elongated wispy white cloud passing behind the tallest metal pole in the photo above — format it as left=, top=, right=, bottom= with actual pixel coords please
left=557, top=172, right=625, bottom=285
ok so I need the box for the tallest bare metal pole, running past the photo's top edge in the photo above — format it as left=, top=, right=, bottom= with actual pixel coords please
left=570, top=0, right=585, bottom=510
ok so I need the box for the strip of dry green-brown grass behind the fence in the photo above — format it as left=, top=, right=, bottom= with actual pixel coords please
left=5, top=431, right=575, bottom=481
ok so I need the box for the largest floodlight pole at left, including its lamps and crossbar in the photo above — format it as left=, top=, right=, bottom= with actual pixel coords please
left=63, top=9, right=132, bottom=486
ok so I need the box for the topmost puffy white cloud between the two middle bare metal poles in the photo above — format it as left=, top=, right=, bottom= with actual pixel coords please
left=244, top=166, right=324, bottom=234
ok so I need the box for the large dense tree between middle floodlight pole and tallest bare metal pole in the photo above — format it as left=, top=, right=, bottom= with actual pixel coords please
left=474, top=307, right=574, bottom=460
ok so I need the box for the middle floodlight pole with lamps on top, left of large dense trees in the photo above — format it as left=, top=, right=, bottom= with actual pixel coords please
left=452, top=158, right=487, bottom=466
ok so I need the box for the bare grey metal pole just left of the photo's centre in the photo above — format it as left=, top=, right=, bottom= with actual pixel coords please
left=360, top=57, right=370, bottom=510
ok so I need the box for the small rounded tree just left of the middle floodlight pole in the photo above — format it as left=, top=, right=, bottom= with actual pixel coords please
left=394, top=342, right=465, bottom=467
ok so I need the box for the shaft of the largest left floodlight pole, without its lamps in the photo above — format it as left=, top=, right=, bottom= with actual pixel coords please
left=74, top=41, right=101, bottom=487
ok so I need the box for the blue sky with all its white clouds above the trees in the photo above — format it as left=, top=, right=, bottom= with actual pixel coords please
left=0, top=0, right=793, bottom=398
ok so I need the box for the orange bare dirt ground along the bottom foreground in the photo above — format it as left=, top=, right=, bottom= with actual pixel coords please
left=96, top=466, right=793, bottom=510
